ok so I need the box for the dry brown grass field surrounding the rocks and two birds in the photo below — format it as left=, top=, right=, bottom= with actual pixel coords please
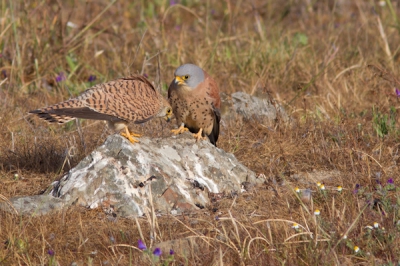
left=0, top=0, right=400, bottom=265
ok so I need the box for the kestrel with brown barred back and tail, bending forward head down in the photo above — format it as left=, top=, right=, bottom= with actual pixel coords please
left=29, top=75, right=172, bottom=143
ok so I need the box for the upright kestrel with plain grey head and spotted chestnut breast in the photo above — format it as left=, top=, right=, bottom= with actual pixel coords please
left=168, top=64, right=221, bottom=146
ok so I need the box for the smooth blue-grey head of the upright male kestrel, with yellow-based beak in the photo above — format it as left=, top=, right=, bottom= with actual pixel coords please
left=174, top=64, right=205, bottom=89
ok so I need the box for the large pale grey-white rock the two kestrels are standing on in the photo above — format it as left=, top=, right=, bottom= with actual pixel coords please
left=2, top=133, right=264, bottom=217
